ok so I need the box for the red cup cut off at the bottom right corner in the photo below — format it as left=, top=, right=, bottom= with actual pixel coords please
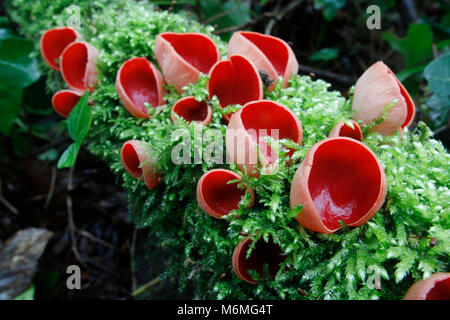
left=403, top=272, right=450, bottom=300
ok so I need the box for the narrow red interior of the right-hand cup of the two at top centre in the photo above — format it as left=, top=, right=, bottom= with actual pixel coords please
left=241, top=32, right=289, bottom=76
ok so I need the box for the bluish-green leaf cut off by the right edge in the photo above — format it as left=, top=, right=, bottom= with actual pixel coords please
left=423, top=54, right=450, bottom=105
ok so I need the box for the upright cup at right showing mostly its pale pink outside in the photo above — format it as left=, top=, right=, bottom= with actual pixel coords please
left=352, top=61, right=415, bottom=135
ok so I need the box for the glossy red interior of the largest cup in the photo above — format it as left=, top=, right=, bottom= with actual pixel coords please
left=308, top=139, right=382, bottom=230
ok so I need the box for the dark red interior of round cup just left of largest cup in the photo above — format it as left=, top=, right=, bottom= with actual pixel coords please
left=201, top=170, right=245, bottom=216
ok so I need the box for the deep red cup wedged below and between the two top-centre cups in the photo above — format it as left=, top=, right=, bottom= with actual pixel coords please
left=208, top=55, right=264, bottom=120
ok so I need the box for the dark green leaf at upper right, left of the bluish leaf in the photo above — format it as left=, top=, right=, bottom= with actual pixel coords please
left=383, top=24, right=433, bottom=68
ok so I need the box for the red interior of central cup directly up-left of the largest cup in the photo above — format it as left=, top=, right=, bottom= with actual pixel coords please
left=241, top=101, right=300, bottom=164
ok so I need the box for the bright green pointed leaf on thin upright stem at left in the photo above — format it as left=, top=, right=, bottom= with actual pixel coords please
left=67, top=91, right=92, bottom=145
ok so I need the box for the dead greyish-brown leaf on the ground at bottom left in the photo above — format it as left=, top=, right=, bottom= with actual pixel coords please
left=0, top=228, right=52, bottom=300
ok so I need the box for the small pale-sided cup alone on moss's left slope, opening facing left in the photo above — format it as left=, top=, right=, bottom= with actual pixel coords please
left=120, top=140, right=161, bottom=190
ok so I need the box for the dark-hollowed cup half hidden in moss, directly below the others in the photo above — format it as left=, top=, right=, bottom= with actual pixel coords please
left=233, top=237, right=286, bottom=284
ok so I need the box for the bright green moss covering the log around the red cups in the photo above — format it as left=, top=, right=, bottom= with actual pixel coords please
left=9, top=0, right=450, bottom=299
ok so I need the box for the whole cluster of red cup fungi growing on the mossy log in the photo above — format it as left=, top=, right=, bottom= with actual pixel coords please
left=41, top=27, right=450, bottom=299
